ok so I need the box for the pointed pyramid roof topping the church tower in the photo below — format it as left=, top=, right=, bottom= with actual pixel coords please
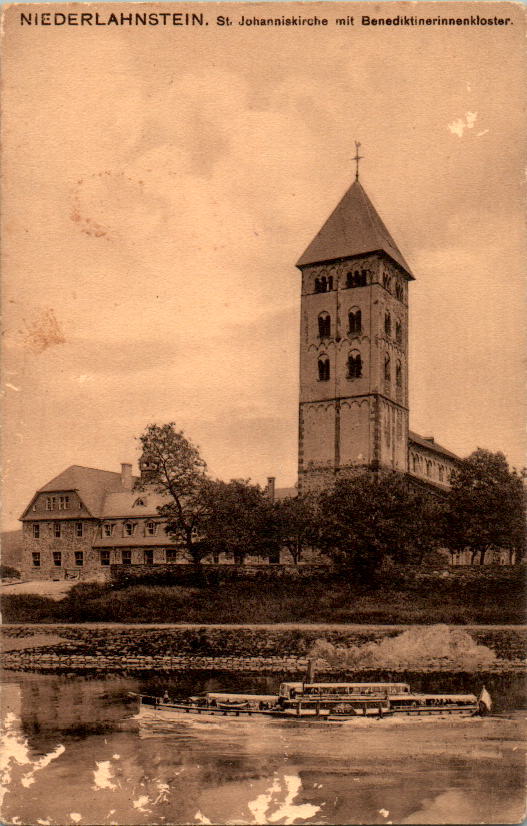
left=297, top=180, right=413, bottom=280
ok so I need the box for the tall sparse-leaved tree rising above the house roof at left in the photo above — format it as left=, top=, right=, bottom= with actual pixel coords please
left=139, top=422, right=207, bottom=565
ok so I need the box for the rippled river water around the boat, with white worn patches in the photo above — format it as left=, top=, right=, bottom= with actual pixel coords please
left=2, top=672, right=526, bottom=826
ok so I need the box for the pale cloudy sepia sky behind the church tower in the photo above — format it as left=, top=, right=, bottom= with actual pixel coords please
left=3, top=2, right=526, bottom=529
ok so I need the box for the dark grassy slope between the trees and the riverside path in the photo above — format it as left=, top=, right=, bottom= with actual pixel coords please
left=2, top=569, right=525, bottom=624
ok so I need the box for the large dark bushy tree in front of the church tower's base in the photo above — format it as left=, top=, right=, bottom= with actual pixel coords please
left=319, top=472, right=442, bottom=582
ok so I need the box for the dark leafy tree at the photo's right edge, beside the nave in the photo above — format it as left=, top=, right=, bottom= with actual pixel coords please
left=447, top=448, right=526, bottom=565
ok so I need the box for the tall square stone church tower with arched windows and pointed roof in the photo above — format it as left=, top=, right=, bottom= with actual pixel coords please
left=297, top=165, right=414, bottom=493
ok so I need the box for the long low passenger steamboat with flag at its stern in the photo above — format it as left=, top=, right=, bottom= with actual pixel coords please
left=130, top=674, right=492, bottom=721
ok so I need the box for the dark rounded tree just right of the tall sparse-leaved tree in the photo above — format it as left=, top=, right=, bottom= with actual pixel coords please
left=199, top=479, right=279, bottom=564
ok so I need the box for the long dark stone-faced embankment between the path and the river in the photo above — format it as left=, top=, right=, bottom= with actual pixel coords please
left=1, top=624, right=527, bottom=672
